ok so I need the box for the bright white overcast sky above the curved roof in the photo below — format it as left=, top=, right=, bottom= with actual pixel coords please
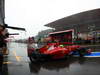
left=5, top=0, right=100, bottom=37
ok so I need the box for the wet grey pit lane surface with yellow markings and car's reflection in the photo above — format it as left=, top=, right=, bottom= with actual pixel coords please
left=0, top=43, right=100, bottom=75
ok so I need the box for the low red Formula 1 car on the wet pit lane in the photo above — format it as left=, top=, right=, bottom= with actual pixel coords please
left=28, top=43, right=91, bottom=61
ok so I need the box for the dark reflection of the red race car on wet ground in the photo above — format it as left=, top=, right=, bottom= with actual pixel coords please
left=29, top=58, right=85, bottom=73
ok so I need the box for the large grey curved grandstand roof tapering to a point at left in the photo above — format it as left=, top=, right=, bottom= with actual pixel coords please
left=45, top=9, right=100, bottom=28
